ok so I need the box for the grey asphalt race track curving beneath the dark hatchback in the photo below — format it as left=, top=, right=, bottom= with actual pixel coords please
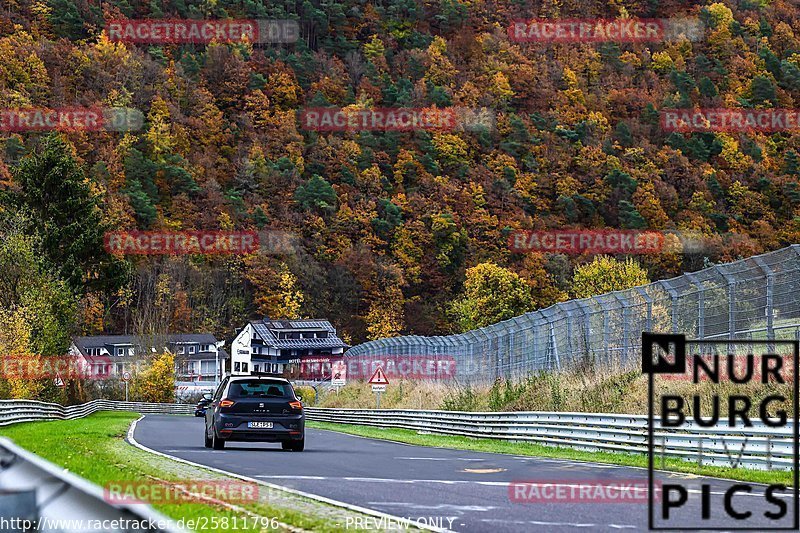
left=134, top=415, right=793, bottom=533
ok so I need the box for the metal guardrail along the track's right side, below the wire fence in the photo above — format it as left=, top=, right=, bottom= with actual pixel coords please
left=306, top=408, right=794, bottom=470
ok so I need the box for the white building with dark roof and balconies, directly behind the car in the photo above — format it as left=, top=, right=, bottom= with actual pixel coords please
left=231, top=318, right=350, bottom=377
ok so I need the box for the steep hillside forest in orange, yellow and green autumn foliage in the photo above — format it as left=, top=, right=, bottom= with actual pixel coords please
left=0, top=0, right=800, bottom=353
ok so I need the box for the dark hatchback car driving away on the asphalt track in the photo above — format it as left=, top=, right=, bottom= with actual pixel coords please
left=205, top=376, right=305, bottom=452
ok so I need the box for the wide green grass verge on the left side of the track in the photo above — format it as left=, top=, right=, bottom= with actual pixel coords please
left=0, top=412, right=410, bottom=532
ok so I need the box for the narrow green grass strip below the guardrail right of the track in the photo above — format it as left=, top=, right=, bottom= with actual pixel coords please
left=306, top=421, right=794, bottom=486
